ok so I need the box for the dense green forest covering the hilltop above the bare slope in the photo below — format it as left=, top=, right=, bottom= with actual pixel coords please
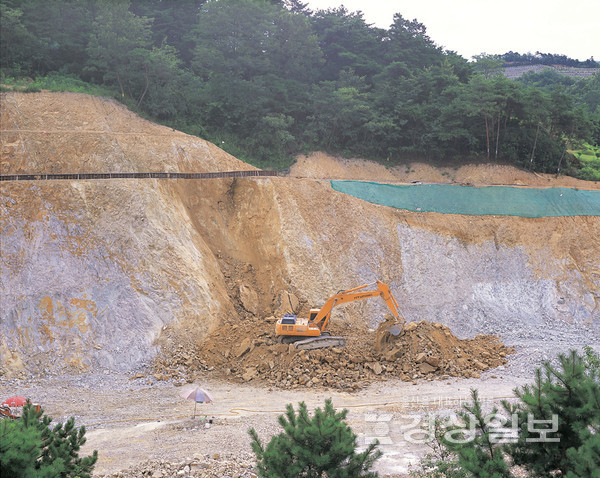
left=0, top=0, right=600, bottom=176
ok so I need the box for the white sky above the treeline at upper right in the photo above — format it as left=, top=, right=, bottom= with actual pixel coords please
left=304, top=0, right=600, bottom=61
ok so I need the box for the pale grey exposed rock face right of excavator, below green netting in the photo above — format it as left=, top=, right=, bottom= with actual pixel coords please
left=396, top=224, right=600, bottom=343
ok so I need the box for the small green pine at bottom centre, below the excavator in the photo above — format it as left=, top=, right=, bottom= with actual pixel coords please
left=249, top=399, right=381, bottom=478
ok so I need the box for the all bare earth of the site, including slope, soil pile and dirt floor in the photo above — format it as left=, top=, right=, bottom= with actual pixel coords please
left=0, top=92, right=600, bottom=478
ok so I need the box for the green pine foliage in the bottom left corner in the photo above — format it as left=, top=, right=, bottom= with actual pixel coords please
left=0, top=403, right=98, bottom=478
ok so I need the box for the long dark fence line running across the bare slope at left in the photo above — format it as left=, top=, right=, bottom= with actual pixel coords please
left=0, top=170, right=279, bottom=181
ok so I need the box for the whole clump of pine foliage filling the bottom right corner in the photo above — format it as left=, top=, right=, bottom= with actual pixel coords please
left=413, top=347, right=600, bottom=478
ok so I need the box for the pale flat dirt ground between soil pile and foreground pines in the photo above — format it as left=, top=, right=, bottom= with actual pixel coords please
left=0, top=370, right=524, bottom=476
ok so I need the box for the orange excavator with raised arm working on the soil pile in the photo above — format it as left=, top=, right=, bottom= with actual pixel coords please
left=275, top=281, right=405, bottom=350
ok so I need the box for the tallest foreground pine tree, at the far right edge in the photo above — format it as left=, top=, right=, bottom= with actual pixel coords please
left=504, top=350, right=600, bottom=477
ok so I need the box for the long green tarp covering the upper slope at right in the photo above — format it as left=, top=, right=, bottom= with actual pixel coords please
left=331, top=181, right=600, bottom=217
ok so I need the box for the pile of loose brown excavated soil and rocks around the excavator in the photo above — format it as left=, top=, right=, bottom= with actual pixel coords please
left=154, top=317, right=514, bottom=391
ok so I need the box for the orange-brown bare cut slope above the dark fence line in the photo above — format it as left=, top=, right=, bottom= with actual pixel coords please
left=0, top=93, right=247, bottom=174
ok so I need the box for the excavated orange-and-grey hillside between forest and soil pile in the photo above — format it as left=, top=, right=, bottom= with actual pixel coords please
left=0, top=93, right=600, bottom=374
